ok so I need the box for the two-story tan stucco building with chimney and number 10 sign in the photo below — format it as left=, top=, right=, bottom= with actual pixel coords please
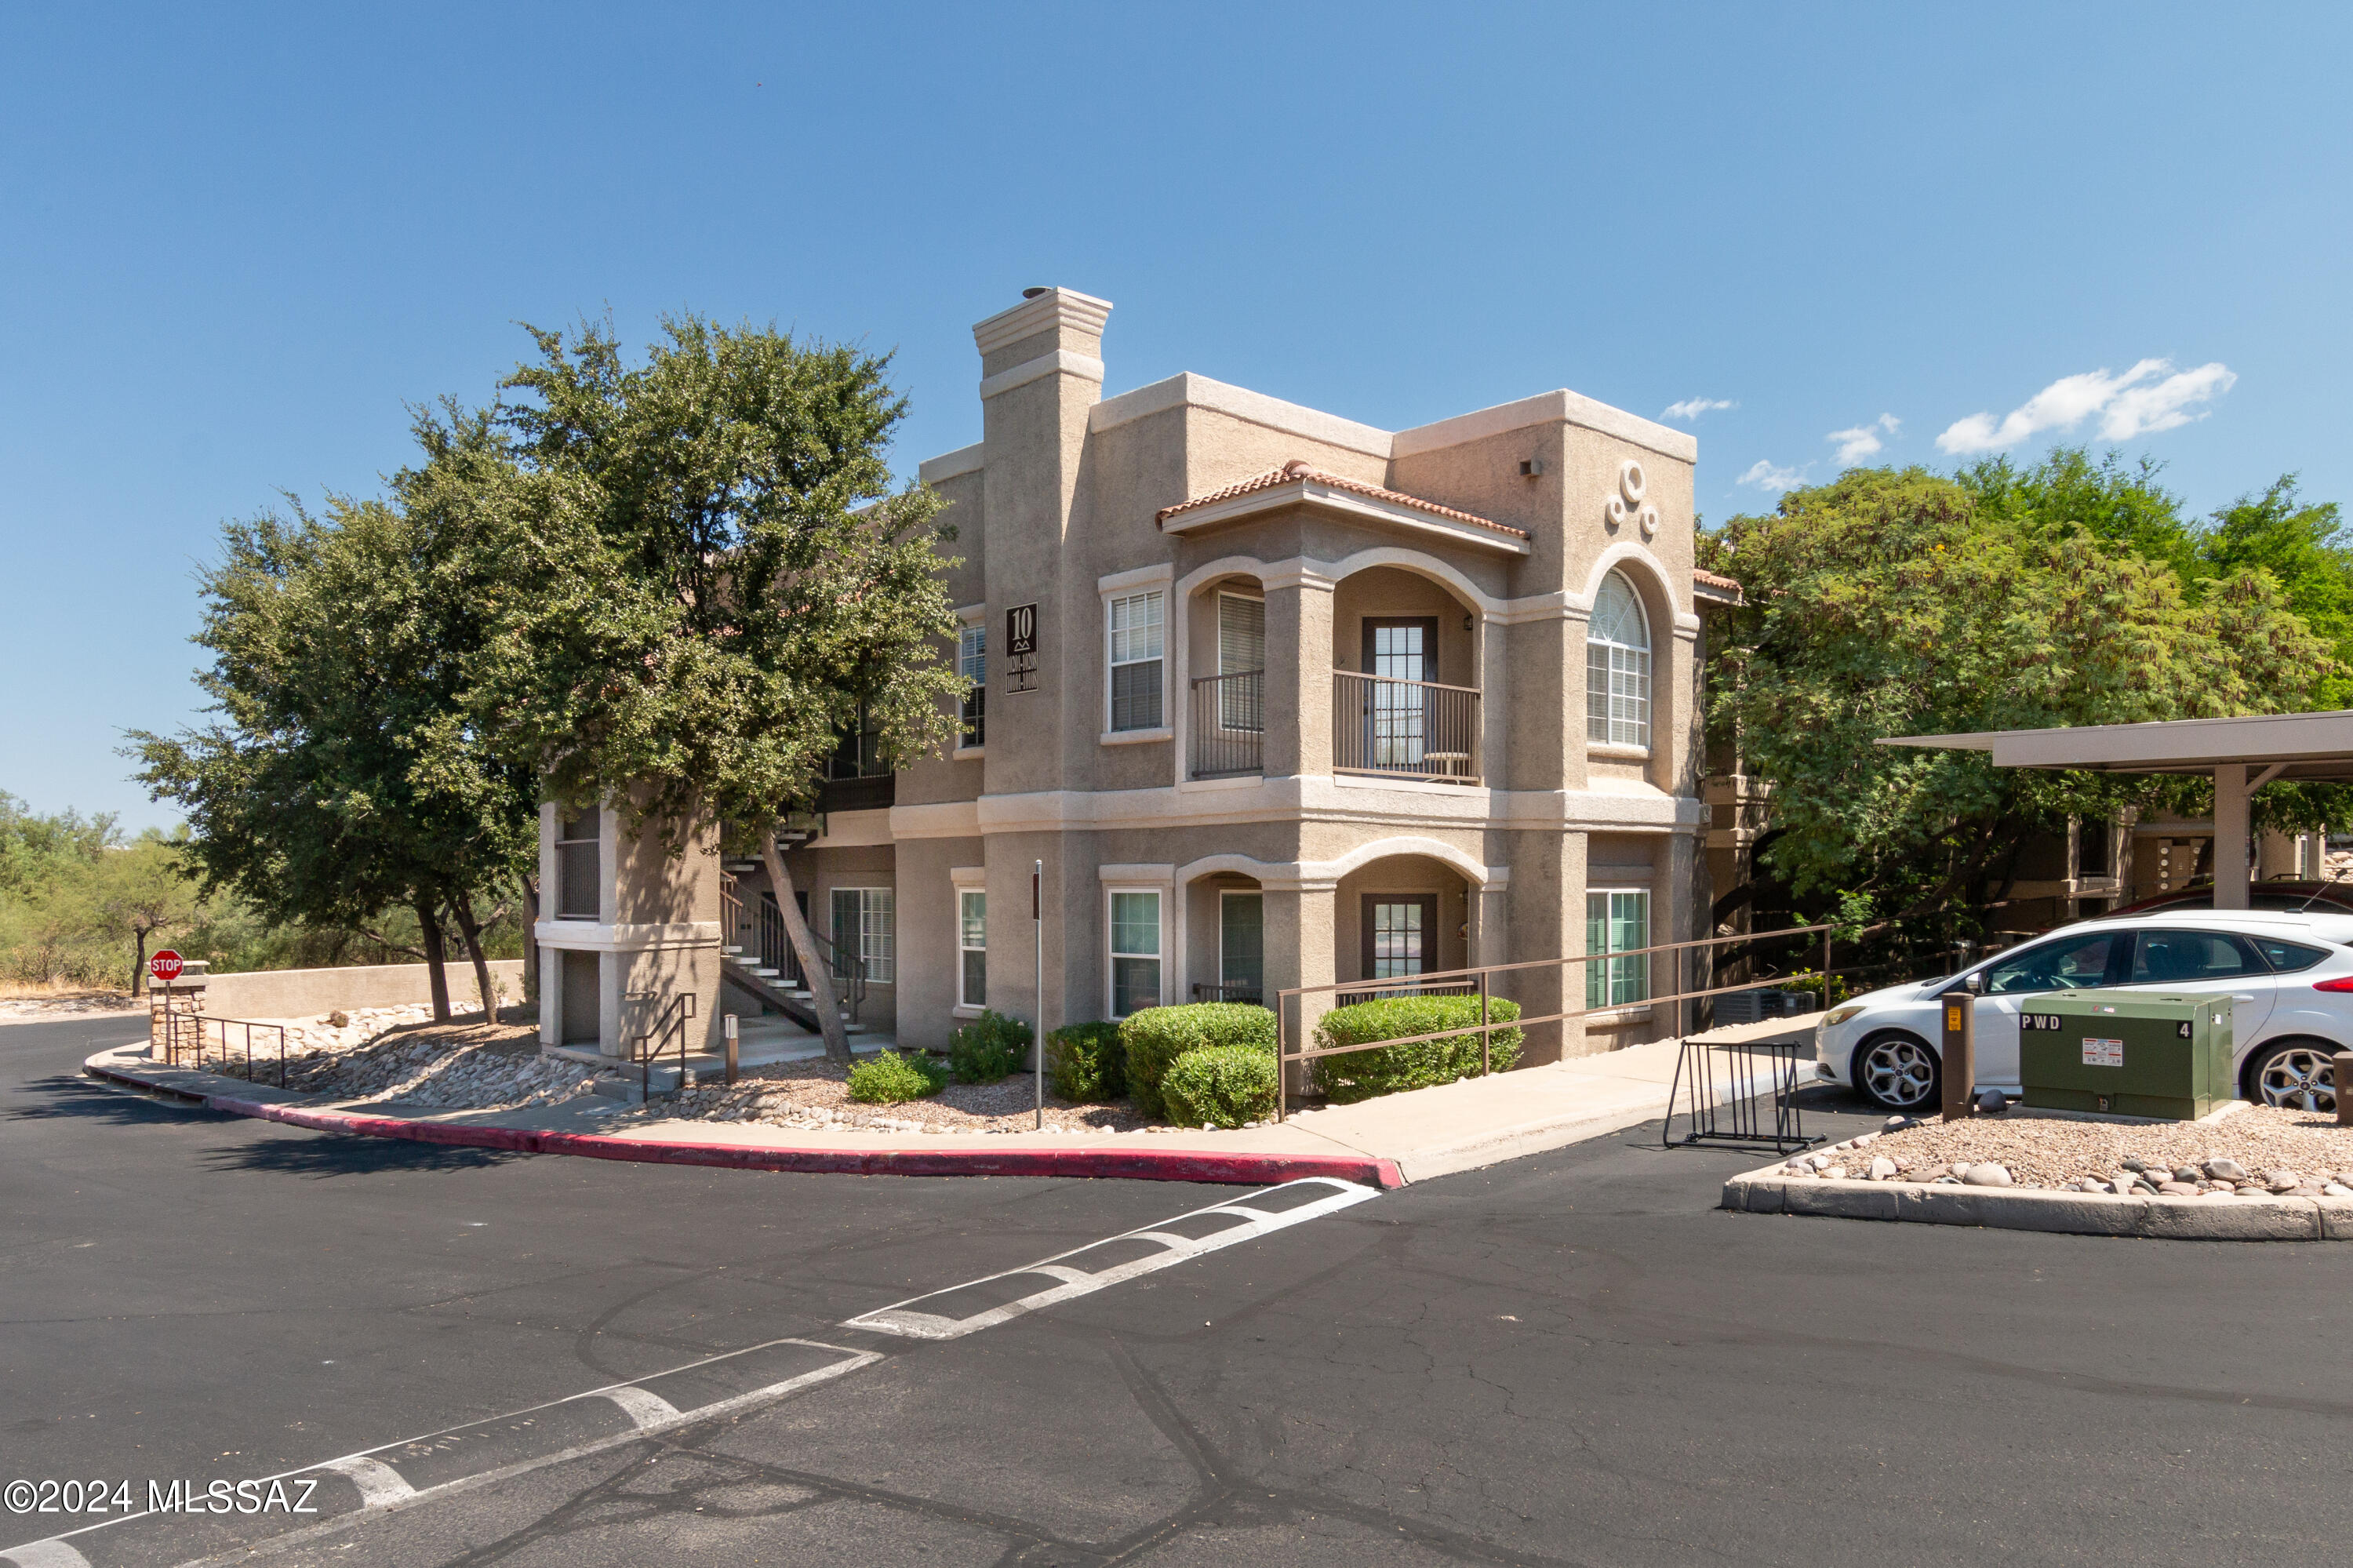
left=536, top=289, right=1739, bottom=1062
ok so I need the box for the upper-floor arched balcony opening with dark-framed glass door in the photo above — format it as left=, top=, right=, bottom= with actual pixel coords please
left=1332, top=565, right=1482, bottom=784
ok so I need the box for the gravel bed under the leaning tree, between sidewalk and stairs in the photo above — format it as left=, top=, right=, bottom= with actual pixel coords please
left=614, top=1060, right=1151, bottom=1133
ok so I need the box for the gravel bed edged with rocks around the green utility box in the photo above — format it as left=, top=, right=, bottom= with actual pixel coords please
left=1774, top=1107, right=2353, bottom=1199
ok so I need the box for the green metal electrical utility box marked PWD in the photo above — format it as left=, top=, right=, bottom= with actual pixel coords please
left=2019, top=991, right=2238, bottom=1121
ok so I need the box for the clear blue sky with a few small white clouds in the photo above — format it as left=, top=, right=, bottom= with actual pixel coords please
left=0, top=2, right=2353, bottom=827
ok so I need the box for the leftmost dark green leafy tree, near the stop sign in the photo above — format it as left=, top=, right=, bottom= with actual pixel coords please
left=132, top=485, right=536, bottom=1020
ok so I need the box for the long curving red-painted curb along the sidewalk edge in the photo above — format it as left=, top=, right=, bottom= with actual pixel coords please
left=82, top=1062, right=1405, bottom=1187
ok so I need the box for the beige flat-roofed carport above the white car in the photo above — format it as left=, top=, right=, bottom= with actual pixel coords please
left=1880, top=708, right=2353, bottom=909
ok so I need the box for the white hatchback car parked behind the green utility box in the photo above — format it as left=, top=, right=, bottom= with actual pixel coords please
left=1814, top=909, right=2353, bottom=1111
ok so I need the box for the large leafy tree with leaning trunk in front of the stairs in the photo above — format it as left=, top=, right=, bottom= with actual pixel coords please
left=456, top=315, right=965, bottom=1062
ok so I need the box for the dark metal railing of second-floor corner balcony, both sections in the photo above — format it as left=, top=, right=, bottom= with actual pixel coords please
left=1188, top=668, right=1480, bottom=784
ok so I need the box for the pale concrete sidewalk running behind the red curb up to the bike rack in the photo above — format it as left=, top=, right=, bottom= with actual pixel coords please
left=87, top=1020, right=1812, bottom=1187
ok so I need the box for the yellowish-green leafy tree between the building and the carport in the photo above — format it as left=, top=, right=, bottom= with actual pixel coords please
left=1701, top=466, right=2334, bottom=919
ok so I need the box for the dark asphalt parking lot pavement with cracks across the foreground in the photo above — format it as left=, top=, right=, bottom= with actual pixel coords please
left=0, top=1022, right=2353, bottom=1568
